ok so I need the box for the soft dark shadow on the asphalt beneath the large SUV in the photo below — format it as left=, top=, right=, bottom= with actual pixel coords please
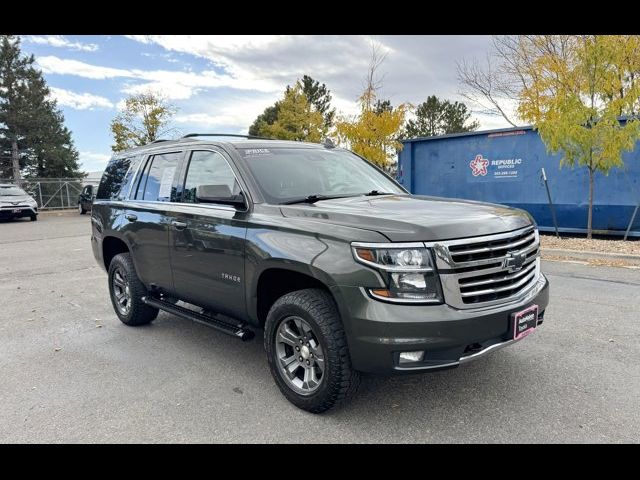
left=147, top=313, right=544, bottom=436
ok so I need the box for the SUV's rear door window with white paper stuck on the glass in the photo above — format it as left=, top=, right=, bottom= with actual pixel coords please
left=135, top=152, right=182, bottom=202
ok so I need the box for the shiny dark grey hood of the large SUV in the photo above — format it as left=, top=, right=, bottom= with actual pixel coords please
left=281, top=195, right=533, bottom=242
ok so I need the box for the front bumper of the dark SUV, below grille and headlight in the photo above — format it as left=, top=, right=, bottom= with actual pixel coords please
left=333, top=274, right=549, bottom=374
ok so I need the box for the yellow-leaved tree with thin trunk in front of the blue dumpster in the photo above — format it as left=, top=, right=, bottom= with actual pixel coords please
left=513, top=35, right=640, bottom=238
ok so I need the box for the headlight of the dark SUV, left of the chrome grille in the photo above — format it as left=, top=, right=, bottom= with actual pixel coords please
left=352, top=243, right=442, bottom=303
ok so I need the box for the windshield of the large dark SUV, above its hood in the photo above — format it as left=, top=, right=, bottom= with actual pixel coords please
left=238, top=148, right=406, bottom=203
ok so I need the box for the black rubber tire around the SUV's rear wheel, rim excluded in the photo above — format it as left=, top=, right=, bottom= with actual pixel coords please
left=109, top=253, right=158, bottom=326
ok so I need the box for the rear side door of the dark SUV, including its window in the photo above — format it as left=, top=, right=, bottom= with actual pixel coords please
left=124, top=151, right=184, bottom=292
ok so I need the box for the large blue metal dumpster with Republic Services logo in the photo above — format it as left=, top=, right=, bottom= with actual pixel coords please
left=397, top=127, right=640, bottom=236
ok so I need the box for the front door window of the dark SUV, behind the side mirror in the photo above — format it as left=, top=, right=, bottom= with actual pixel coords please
left=182, top=151, right=241, bottom=203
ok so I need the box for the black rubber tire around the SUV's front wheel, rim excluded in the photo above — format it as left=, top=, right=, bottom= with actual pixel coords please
left=264, top=288, right=360, bottom=413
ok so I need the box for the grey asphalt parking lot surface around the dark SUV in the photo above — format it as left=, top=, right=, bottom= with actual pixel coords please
left=0, top=213, right=640, bottom=443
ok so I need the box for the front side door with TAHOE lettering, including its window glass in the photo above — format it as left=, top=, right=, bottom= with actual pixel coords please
left=169, top=150, right=247, bottom=318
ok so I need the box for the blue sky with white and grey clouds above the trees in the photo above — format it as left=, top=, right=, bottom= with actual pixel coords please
left=22, top=35, right=508, bottom=171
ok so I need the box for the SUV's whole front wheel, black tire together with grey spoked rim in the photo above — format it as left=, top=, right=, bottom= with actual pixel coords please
left=264, top=288, right=360, bottom=413
